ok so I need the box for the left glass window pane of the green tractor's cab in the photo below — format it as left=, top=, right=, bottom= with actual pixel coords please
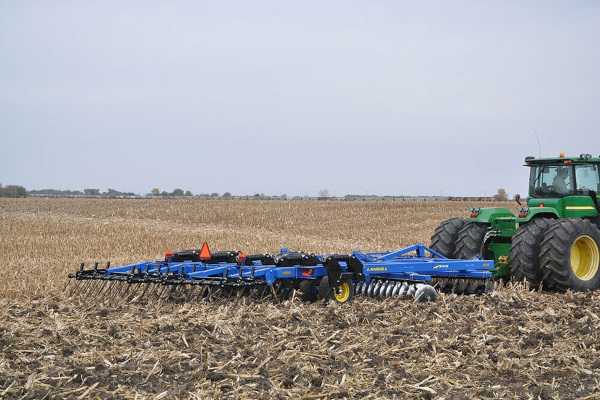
left=529, top=164, right=574, bottom=198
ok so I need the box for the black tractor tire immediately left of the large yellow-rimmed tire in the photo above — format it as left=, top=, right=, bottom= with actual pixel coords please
left=510, top=218, right=556, bottom=290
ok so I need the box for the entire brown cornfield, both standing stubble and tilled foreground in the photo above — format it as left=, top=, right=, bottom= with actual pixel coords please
left=0, top=199, right=600, bottom=399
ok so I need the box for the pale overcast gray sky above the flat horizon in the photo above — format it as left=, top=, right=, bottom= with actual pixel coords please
left=0, top=0, right=600, bottom=196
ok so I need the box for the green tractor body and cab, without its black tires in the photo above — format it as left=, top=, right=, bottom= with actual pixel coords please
left=469, top=154, right=600, bottom=277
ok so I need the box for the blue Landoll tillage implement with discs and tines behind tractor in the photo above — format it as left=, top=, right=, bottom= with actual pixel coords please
left=69, top=243, right=494, bottom=308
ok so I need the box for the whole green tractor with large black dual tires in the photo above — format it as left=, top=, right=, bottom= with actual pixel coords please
left=430, top=154, right=600, bottom=291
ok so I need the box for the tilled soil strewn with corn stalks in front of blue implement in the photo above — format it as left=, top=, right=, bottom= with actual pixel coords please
left=0, top=285, right=600, bottom=399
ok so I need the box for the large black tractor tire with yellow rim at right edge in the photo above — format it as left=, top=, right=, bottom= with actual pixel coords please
left=540, top=218, right=600, bottom=291
